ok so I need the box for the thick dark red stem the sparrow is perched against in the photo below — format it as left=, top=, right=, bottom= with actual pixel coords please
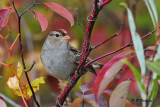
left=56, top=0, right=111, bottom=107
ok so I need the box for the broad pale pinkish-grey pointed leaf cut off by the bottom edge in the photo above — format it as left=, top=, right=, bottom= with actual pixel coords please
left=109, top=81, right=131, bottom=107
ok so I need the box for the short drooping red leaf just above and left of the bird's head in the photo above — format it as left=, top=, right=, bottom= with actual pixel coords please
left=28, top=10, right=48, bottom=31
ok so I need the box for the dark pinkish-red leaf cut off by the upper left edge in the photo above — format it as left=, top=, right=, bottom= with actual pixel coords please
left=0, top=8, right=11, bottom=30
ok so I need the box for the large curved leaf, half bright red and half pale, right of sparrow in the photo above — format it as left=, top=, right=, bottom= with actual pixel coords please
left=94, top=51, right=133, bottom=100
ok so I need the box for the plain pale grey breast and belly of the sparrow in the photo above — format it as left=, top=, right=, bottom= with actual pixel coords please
left=41, top=50, right=76, bottom=80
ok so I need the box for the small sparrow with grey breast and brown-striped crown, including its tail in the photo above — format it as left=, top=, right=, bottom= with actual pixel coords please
left=41, top=29, right=103, bottom=80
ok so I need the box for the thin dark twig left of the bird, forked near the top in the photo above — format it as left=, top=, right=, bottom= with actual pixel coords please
left=11, top=0, right=40, bottom=107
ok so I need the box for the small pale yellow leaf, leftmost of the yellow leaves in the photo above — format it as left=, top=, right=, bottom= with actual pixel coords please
left=7, top=76, right=19, bottom=90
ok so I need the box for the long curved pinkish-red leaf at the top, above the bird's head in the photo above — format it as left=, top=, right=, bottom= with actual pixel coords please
left=43, top=2, right=74, bottom=26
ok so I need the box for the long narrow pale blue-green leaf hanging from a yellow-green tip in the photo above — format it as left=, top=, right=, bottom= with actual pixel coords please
left=121, top=3, right=146, bottom=76
